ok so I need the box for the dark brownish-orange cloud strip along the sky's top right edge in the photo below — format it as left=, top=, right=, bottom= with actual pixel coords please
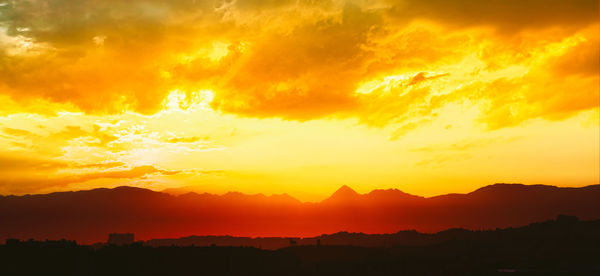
left=386, top=0, right=598, bottom=32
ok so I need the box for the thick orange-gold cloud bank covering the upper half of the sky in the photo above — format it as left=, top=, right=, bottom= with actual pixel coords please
left=0, top=0, right=599, bottom=130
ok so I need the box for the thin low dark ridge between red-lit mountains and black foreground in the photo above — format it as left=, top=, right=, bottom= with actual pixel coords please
left=146, top=215, right=600, bottom=250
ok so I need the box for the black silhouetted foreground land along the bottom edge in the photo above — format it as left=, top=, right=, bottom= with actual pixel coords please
left=0, top=216, right=600, bottom=275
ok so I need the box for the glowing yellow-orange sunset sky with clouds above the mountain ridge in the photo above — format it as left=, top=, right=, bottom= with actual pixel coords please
left=0, top=0, right=600, bottom=201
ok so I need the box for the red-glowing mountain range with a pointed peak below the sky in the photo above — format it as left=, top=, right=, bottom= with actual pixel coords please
left=0, top=184, right=600, bottom=243
